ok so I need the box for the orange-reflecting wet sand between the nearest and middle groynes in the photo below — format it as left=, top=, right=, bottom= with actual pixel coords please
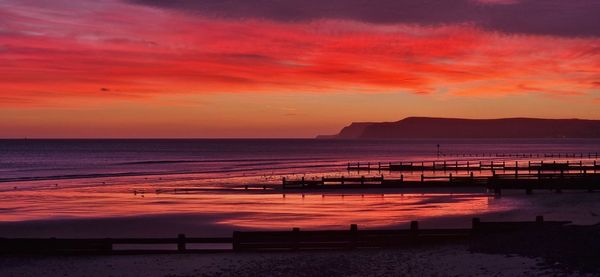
left=0, top=189, right=600, bottom=238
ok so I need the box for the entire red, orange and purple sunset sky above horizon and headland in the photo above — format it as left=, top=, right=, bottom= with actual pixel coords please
left=0, top=0, right=600, bottom=138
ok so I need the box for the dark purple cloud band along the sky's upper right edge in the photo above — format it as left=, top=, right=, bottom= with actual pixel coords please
left=126, top=0, right=600, bottom=37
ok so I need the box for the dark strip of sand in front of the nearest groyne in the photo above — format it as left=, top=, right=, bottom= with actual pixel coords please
left=0, top=245, right=594, bottom=277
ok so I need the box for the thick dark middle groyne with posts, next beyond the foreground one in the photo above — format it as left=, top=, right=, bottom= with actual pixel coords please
left=282, top=171, right=600, bottom=194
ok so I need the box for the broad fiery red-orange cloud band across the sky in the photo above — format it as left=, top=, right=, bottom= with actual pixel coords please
left=0, top=2, right=600, bottom=106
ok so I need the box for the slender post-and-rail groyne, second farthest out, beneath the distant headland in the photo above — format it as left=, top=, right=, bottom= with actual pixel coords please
left=346, top=160, right=600, bottom=172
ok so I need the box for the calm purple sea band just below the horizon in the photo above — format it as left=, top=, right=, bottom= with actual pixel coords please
left=0, top=139, right=600, bottom=182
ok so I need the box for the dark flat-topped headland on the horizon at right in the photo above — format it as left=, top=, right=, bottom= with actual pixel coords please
left=317, top=117, right=600, bottom=139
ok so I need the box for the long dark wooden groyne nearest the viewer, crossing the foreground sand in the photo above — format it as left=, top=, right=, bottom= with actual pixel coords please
left=0, top=216, right=569, bottom=252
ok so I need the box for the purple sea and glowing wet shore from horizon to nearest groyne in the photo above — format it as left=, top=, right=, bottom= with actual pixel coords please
left=0, top=139, right=600, bottom=237
